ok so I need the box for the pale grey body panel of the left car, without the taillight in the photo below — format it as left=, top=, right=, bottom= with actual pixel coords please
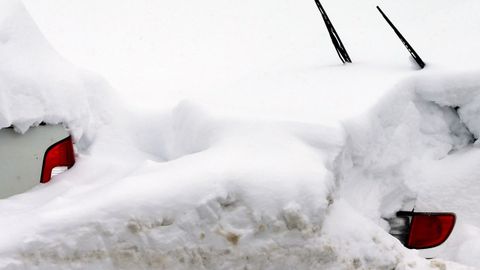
left=0, top=125, right=70, bottom=198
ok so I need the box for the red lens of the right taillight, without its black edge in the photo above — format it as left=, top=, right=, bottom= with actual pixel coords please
left=407, top=213, right=456, bottom=249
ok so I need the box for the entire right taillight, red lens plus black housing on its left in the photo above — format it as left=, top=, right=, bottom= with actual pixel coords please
left=392, top=211, right=456, bottom=249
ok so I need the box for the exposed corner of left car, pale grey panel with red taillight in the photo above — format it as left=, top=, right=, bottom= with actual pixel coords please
left=0, top=124, right=75, bottom=198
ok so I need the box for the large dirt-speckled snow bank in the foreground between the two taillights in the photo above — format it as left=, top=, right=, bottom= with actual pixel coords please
left=0, top=103, right=460, bottom=269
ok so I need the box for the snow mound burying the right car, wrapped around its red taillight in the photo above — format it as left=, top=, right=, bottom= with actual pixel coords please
left=338, top=71, right=480, bottom=267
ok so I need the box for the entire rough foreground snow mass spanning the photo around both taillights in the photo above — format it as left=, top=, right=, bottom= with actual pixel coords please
left=0, top=0, right=480, bottom=269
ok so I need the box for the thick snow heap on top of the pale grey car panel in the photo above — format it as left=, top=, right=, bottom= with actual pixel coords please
left=0, top=0, right=109, bottom=146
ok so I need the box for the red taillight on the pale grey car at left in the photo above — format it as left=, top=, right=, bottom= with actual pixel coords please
left=40, top=137, right=75, bottom=183
